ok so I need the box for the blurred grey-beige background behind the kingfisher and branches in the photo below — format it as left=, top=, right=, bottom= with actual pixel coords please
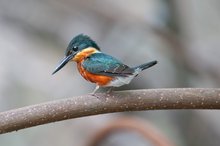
left=0, top=0, right=220, bottom=146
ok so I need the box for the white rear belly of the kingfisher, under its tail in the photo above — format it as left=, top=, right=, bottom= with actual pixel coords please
left=105, top=75, right=135, bottom=87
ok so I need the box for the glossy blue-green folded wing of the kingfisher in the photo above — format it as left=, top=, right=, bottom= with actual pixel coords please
left=82, top=53, right=134, bottom=76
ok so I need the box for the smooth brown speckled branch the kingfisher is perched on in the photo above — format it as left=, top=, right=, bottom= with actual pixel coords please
left=0, top=88, right=220, bottom=133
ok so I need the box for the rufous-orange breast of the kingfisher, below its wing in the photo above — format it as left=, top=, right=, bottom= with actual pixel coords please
left=77, top=61, right=112, bottom=86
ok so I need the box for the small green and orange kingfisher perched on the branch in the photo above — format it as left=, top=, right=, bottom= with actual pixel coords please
left=52, top=34, right=157, bottom=95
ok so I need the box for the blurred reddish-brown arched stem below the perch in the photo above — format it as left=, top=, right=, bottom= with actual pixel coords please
left=87, top=117, right=175, bottom=146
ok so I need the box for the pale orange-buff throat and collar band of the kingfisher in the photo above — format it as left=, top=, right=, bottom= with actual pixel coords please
left=73, top=47, right=99, bottom=63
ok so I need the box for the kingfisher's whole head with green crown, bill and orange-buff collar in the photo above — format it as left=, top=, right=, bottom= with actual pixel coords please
left=52, top=34, right=100, bottom=74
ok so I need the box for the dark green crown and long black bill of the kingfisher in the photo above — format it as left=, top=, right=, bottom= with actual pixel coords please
left=52, top=34, right=100, bottom=74
